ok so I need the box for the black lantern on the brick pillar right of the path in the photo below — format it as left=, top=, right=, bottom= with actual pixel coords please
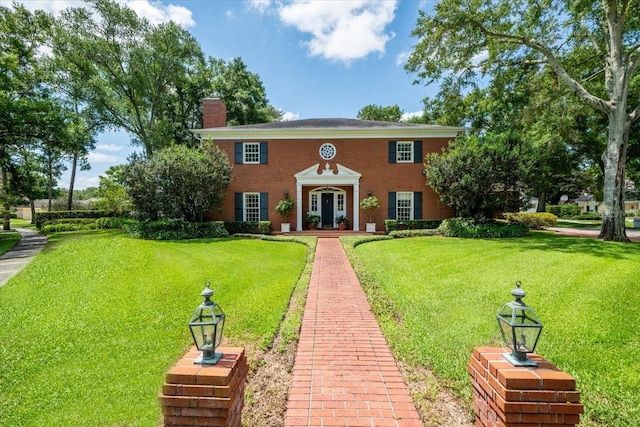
left=497, top=282, right=542, bottom=366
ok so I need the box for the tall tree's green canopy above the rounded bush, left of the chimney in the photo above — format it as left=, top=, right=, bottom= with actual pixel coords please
left=54, top=0, right=206, bottom=155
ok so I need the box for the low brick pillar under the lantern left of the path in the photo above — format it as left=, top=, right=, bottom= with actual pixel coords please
left=160, top=347, right=249, bottom=427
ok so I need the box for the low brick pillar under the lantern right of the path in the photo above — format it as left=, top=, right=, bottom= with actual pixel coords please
left=467, top=347, right=584, bottom=427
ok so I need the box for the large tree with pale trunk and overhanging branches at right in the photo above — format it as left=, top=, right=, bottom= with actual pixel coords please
left=407, top=0, right=640, bottom=241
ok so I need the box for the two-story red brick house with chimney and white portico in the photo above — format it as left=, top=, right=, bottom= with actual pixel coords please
left=193, top=99, right=465, bottom=231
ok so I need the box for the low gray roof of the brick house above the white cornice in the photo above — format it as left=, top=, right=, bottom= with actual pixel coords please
left=229, top=119, right=439, bottom=129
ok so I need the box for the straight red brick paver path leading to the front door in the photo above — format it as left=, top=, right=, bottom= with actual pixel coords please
left=285, top=238, right=422, bottom=427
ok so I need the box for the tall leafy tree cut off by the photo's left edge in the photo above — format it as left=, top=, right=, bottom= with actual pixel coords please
left=0, top=5, right=68, bottom=230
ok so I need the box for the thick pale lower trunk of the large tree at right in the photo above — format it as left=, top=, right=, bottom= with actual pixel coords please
left=599, top=110, right=630, bottom=242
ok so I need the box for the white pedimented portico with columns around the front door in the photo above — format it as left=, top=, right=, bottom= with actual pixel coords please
left=294, top=163, right=362, bottom=231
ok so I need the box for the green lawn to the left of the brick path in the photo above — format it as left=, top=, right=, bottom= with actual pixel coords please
left=0, top=231, right=306, bottom=427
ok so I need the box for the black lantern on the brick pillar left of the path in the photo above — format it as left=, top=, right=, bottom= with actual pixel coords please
left=189, top=282, right=225, bottom=365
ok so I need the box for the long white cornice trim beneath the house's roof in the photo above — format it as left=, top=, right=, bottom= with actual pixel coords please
left=191, top=126, right=467, bottom=141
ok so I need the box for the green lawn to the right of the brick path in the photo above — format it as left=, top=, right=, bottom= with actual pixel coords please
left=348, top=233, right=640, bottom=426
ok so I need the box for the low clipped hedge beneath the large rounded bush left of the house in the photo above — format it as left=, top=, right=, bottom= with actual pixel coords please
left=125, top=219, right=229, bottom=240
